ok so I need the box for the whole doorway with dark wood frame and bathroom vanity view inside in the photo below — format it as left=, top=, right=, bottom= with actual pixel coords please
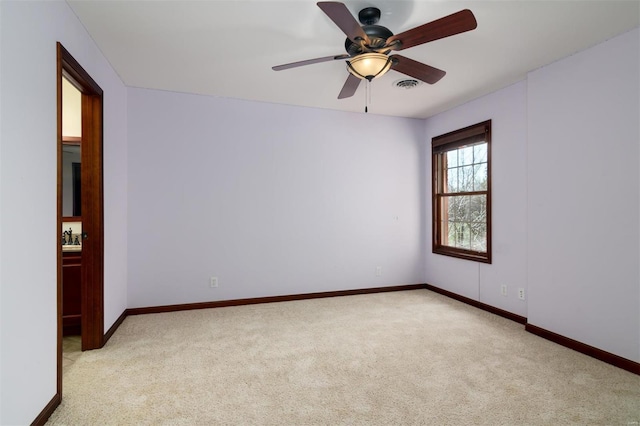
left=57, top=43, right=104, bottom=396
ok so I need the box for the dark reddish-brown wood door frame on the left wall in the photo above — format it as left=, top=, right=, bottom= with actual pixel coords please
left=56, top=43, right=104, bottom=396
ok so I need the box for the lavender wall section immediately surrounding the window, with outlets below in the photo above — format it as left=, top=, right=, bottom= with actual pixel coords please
left=424, top=82, right=527, bottom=316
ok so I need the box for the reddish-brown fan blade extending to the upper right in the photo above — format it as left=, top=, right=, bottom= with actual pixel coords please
left=387, top=9, right=478, bottom=50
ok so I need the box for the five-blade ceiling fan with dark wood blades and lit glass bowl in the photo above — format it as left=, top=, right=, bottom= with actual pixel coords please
left=272, top=1, right=478, bottom=99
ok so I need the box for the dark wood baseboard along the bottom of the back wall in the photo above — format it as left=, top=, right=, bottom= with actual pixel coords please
left=126, top=284, right=425, bottom=315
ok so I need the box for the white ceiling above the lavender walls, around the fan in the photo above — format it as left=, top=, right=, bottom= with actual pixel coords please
left=67, top=0, right=640, bottom=118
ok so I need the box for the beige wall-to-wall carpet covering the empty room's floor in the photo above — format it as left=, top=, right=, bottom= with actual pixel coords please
left=49, top=290, right=640, bottom=425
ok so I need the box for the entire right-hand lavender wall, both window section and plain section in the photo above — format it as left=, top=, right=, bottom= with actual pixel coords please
left=425, top=29, right=640, bottom=361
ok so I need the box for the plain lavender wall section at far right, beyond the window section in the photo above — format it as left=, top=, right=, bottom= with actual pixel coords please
left=527, top=29, right=640, bottom=361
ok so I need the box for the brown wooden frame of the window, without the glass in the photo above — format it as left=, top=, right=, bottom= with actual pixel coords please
left=431, top=120, right=491, bottom=264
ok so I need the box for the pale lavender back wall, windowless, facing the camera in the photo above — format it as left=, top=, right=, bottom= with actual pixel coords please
left=128, top=89, right=424, bottom=307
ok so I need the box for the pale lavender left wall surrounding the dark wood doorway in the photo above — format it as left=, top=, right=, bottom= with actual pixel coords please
left=0, top=1, right=127, bottom=424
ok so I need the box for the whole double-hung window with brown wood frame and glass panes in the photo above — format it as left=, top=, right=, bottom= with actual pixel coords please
left=431, top=120, right=491, bottom=263
